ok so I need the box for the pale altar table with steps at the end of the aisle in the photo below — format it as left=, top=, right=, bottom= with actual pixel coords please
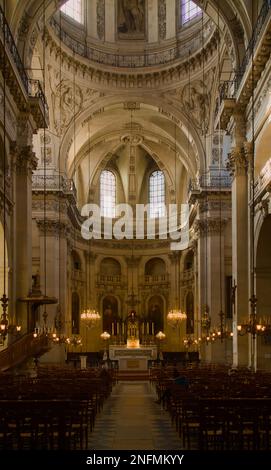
left=109, top=345, right=157, bottom=371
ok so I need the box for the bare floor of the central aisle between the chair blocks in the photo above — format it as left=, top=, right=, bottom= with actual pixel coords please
left=89, top=381, right=181, bottom=450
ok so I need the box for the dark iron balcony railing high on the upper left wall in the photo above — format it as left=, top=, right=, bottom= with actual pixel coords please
left=0, top=6, right=48, bottom=114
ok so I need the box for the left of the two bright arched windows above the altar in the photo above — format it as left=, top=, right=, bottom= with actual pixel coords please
left=100, top=170, right=116, bottom=218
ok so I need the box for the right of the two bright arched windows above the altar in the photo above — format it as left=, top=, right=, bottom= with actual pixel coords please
left=149, top=170, right=166, bottom=218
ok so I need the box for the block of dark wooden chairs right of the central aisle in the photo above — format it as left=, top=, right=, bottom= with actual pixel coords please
left=151, top=365, right=271, bottom=451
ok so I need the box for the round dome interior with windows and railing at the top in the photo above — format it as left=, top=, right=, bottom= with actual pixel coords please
left=48, top=0, right=215, bottom=70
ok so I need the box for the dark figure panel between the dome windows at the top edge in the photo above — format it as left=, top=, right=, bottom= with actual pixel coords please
left=118, top=0, right=145, bottom=38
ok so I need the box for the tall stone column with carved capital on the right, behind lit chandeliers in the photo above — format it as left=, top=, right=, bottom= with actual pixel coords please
left=229, top=146, right=249, bottom=367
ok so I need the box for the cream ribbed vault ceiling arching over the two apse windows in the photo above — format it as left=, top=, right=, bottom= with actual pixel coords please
left=60, top=102, right=203, bottom=204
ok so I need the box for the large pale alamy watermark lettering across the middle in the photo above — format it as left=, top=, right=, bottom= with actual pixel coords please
left=81, top=204, right=189, bottom=251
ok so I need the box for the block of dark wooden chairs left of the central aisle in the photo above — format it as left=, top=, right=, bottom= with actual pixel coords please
left=0, top=367, right=115, bottom=450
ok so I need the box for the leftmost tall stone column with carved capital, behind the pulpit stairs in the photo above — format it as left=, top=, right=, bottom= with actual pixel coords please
left=12, top=146, right=37, bottom=332
